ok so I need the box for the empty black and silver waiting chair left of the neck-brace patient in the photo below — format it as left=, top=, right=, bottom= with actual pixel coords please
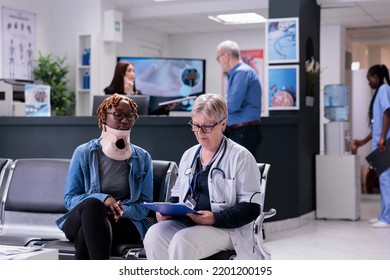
left=0, top=158, right=70, bottom=246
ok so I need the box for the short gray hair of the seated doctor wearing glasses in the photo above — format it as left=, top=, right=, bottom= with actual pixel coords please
left=191, top=93, right=227, bottom=122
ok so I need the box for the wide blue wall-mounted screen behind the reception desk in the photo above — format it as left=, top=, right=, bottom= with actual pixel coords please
left=117, top=57, right=206, bottom=111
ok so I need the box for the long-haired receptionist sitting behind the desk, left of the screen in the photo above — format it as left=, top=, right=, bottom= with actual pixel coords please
left=104, top=61, right=141, bottom=95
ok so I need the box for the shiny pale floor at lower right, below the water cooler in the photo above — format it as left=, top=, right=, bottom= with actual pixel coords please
left=265, top=194, right=390, bottom=260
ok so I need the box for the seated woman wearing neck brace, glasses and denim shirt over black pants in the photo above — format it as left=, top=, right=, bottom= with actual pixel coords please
left=56, top=94, right=153, bottom=260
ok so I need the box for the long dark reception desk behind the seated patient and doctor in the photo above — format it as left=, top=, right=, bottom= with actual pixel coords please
left=0, top=116, right=319, bottom=221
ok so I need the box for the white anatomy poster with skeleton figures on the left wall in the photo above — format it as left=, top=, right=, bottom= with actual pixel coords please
left=2, top=7, right=35, bottom=81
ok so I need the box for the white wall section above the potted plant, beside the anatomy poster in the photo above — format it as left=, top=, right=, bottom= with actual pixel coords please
left=0, top=0, right=102, bottom=90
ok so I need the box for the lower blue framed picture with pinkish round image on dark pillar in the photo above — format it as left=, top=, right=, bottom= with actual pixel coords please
left=268, top=65, right=299, bottom=110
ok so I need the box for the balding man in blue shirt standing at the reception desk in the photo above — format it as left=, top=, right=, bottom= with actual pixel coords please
left=216, top=40, right=263, bottom=158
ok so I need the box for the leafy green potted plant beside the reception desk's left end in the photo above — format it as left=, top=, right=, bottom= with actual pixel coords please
left=33, top=53, right=75, bottom=116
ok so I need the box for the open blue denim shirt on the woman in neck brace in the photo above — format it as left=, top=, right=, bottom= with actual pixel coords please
left=56, top=139, right=153, bottom=238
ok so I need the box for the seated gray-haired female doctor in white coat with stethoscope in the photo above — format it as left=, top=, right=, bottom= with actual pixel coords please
left=144, top=94, right=261, bottom=260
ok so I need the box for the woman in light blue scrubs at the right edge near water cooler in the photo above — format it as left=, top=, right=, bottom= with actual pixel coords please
left=351, top=64, right=390, bottom=228
